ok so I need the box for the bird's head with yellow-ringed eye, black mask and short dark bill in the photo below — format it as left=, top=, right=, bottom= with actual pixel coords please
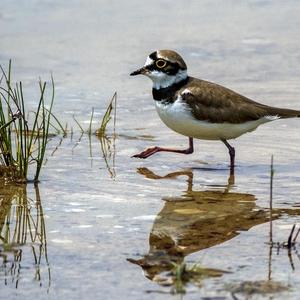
left=130, top=50, right=187, bottom=89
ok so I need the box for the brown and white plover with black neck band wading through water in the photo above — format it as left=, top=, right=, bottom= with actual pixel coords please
left=130, top=50, right=300, bottom=174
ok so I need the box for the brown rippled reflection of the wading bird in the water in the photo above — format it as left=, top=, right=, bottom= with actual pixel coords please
left=128, top=168, right=300, bottom=292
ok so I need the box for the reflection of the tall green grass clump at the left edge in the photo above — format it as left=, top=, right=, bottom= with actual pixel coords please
left=0, top=184, right=51, bottom=291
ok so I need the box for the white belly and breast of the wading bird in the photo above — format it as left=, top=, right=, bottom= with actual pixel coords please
left=155, top=98, right=278, bottom=140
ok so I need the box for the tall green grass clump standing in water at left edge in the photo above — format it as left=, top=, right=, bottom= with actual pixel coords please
left=0, top=62, right=54, bottom=182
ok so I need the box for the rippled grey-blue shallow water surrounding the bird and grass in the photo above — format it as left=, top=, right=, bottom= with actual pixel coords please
left=0, top=0, right=300, bottom=299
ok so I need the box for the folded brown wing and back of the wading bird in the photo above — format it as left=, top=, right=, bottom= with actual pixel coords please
left=181, top=78, right=300, bottom=123
